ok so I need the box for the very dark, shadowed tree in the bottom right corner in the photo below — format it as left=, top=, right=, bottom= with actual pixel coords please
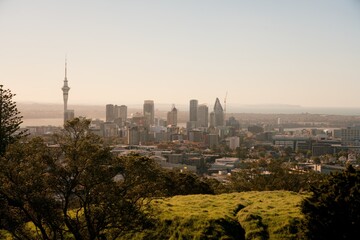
left=301, top=165, right=360, bottom=239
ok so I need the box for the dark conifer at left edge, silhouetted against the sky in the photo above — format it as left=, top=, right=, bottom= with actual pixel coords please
left=0, top=85, right=26, bottom=156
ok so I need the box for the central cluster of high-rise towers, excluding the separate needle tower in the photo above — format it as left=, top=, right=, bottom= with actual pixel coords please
left=87, top=98, right=240, bottom=149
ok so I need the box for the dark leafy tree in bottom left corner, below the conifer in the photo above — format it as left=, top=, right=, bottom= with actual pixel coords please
left=0, top=138, right=61, bottom=239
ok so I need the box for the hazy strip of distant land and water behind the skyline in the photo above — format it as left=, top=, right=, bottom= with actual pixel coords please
left=17, top=102, right=360, bottom=118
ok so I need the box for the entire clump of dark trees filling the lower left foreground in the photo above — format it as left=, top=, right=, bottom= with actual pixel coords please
left=0, top=118, right=158, bottom=239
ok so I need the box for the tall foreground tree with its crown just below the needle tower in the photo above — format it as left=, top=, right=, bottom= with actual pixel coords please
left=50, top=118, right=152, bottom=239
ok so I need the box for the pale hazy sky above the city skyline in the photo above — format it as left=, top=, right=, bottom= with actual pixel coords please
left=0, top=0, right=360, bottom=107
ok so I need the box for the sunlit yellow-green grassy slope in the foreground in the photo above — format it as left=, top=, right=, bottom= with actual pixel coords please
left=127, top=191, right=305, bottom=239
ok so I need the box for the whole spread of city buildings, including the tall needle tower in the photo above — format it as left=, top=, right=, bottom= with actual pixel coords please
left=23, top=61, right=360, bottom=176
